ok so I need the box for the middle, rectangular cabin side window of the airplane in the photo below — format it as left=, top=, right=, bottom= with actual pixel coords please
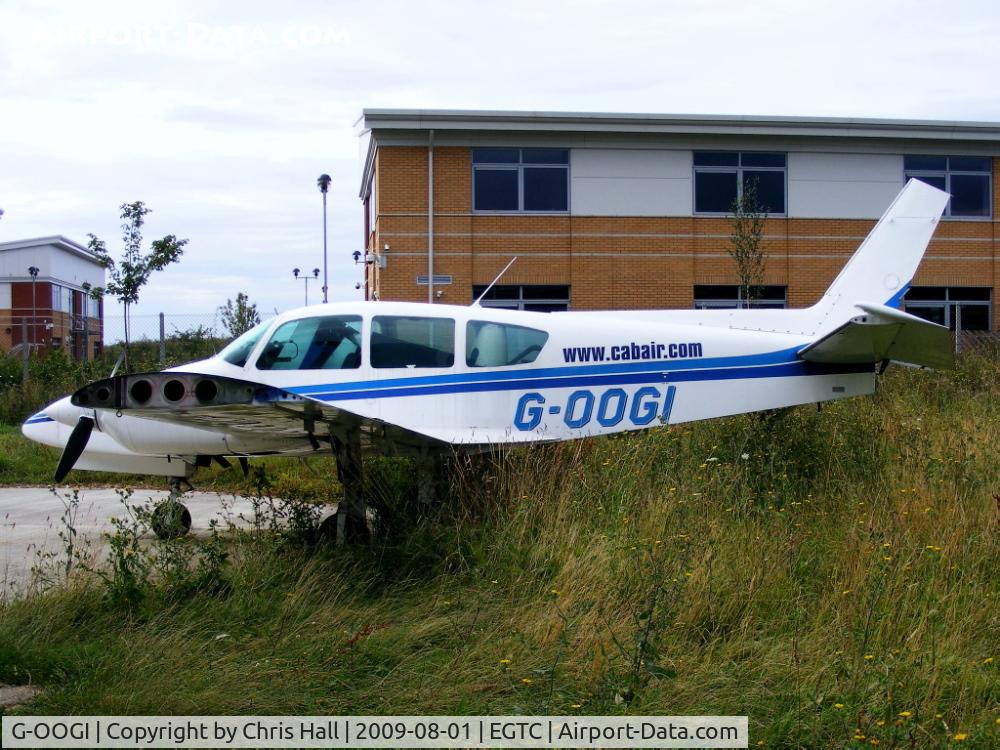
left=371, top=315, right=455, bottom=368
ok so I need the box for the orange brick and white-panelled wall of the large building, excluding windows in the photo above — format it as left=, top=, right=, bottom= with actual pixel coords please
left=369, top=146, right=1000, bottom=329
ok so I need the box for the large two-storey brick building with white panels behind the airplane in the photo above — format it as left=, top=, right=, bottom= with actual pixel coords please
left=361, top=109, right=1000, bottom=330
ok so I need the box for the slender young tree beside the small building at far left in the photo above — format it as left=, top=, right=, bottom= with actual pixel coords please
left=87, top=201, right=187, bottom=372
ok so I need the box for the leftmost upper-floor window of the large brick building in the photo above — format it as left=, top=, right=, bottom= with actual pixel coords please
left=472, top=148, right=569, bottom=213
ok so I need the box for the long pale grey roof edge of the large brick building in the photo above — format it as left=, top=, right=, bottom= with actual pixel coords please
left=361, top=108, right=1000, bottom=134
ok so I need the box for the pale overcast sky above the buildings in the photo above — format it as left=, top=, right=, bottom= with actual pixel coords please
left=0, top=0, right=1000, bottom=328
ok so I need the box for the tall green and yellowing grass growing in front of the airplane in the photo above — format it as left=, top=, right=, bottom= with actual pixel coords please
left=0, top=353, right=1000, bottom=747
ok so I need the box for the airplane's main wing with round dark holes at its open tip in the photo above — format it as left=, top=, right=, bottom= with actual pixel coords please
left=72, top=372, right=444, bottom=447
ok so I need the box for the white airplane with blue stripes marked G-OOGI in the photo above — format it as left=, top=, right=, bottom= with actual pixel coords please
left=22, top=180, right=953, bottom=540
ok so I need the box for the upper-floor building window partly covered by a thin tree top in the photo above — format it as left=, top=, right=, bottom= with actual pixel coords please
left=694, top=151, right=786, bottom=214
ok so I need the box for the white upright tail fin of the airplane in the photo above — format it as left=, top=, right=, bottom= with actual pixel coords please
left=812, top=180, right=950, bottom=332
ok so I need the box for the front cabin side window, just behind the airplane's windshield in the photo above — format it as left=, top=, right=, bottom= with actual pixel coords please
left=257, top=315, right=361, bottom=370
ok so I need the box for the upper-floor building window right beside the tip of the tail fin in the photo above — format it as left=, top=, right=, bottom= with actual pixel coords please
left=903, top=156, right=993, bottom=218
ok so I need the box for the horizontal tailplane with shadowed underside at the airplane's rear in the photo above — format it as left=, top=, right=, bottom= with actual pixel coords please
left=799, top=302, right=955, bottom=370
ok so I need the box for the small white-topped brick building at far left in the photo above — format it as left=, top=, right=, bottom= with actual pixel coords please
left=0, top=237, right=104, bottom=359
